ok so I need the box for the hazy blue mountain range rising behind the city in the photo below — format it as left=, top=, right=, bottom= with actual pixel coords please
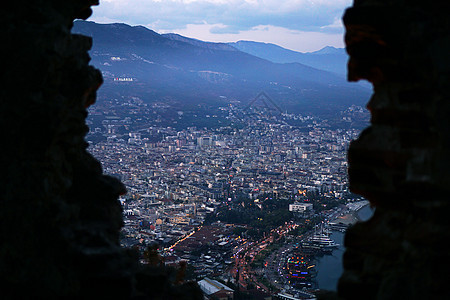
left=72, top=21, right=370, bottom=113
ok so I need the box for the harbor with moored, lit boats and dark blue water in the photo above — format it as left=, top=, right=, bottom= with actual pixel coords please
left=278, top=201, right=374, bottom=299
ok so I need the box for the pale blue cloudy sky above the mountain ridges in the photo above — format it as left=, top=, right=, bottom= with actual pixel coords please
left=89, top=0, right=352, bottom=52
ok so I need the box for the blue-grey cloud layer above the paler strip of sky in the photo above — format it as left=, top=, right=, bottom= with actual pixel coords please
left=92, top=0, right=351, bottom=33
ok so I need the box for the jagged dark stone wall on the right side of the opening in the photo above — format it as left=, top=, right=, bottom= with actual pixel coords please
left=338, top=0, right=450, bottom=299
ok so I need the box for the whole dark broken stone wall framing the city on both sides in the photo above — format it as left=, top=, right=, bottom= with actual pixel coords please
left=0, top=0, right=450, bottom=299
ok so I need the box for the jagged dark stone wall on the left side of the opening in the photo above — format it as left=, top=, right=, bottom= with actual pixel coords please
left=0, top=0, right=202, bottom=299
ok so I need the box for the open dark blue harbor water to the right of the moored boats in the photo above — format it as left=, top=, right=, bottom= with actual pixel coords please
left=316, top=205, right=374, bottom=291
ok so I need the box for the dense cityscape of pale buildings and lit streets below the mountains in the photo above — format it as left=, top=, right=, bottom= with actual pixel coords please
left=87, top=99, right=367, bottom=299
